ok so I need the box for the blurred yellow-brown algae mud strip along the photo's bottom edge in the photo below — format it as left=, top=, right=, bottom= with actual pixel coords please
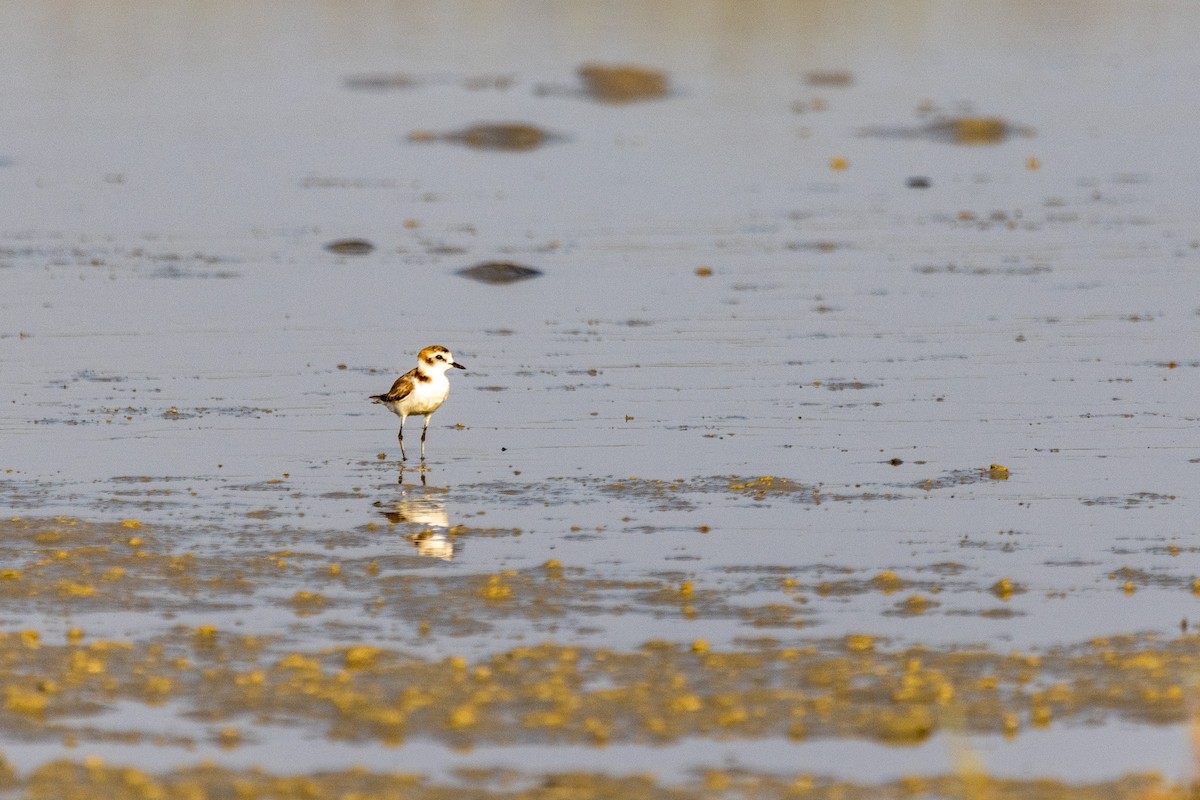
left=7, top=760, right=1171, bottom=800
